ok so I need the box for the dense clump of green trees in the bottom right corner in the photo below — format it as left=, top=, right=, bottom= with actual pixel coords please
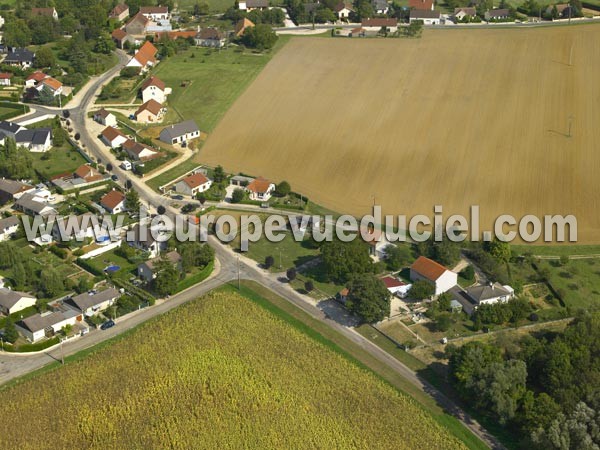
left=447, top=313, right=600, bottom=450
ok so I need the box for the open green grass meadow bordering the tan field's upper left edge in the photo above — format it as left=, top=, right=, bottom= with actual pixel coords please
left=154, top=37, right=289, bottom=132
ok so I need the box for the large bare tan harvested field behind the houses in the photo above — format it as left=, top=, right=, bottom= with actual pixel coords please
left=200, top=25, right=600, bottom=243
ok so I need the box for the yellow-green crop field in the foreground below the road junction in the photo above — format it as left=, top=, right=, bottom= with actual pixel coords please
left=0, top=292, right=464, bottom=450
